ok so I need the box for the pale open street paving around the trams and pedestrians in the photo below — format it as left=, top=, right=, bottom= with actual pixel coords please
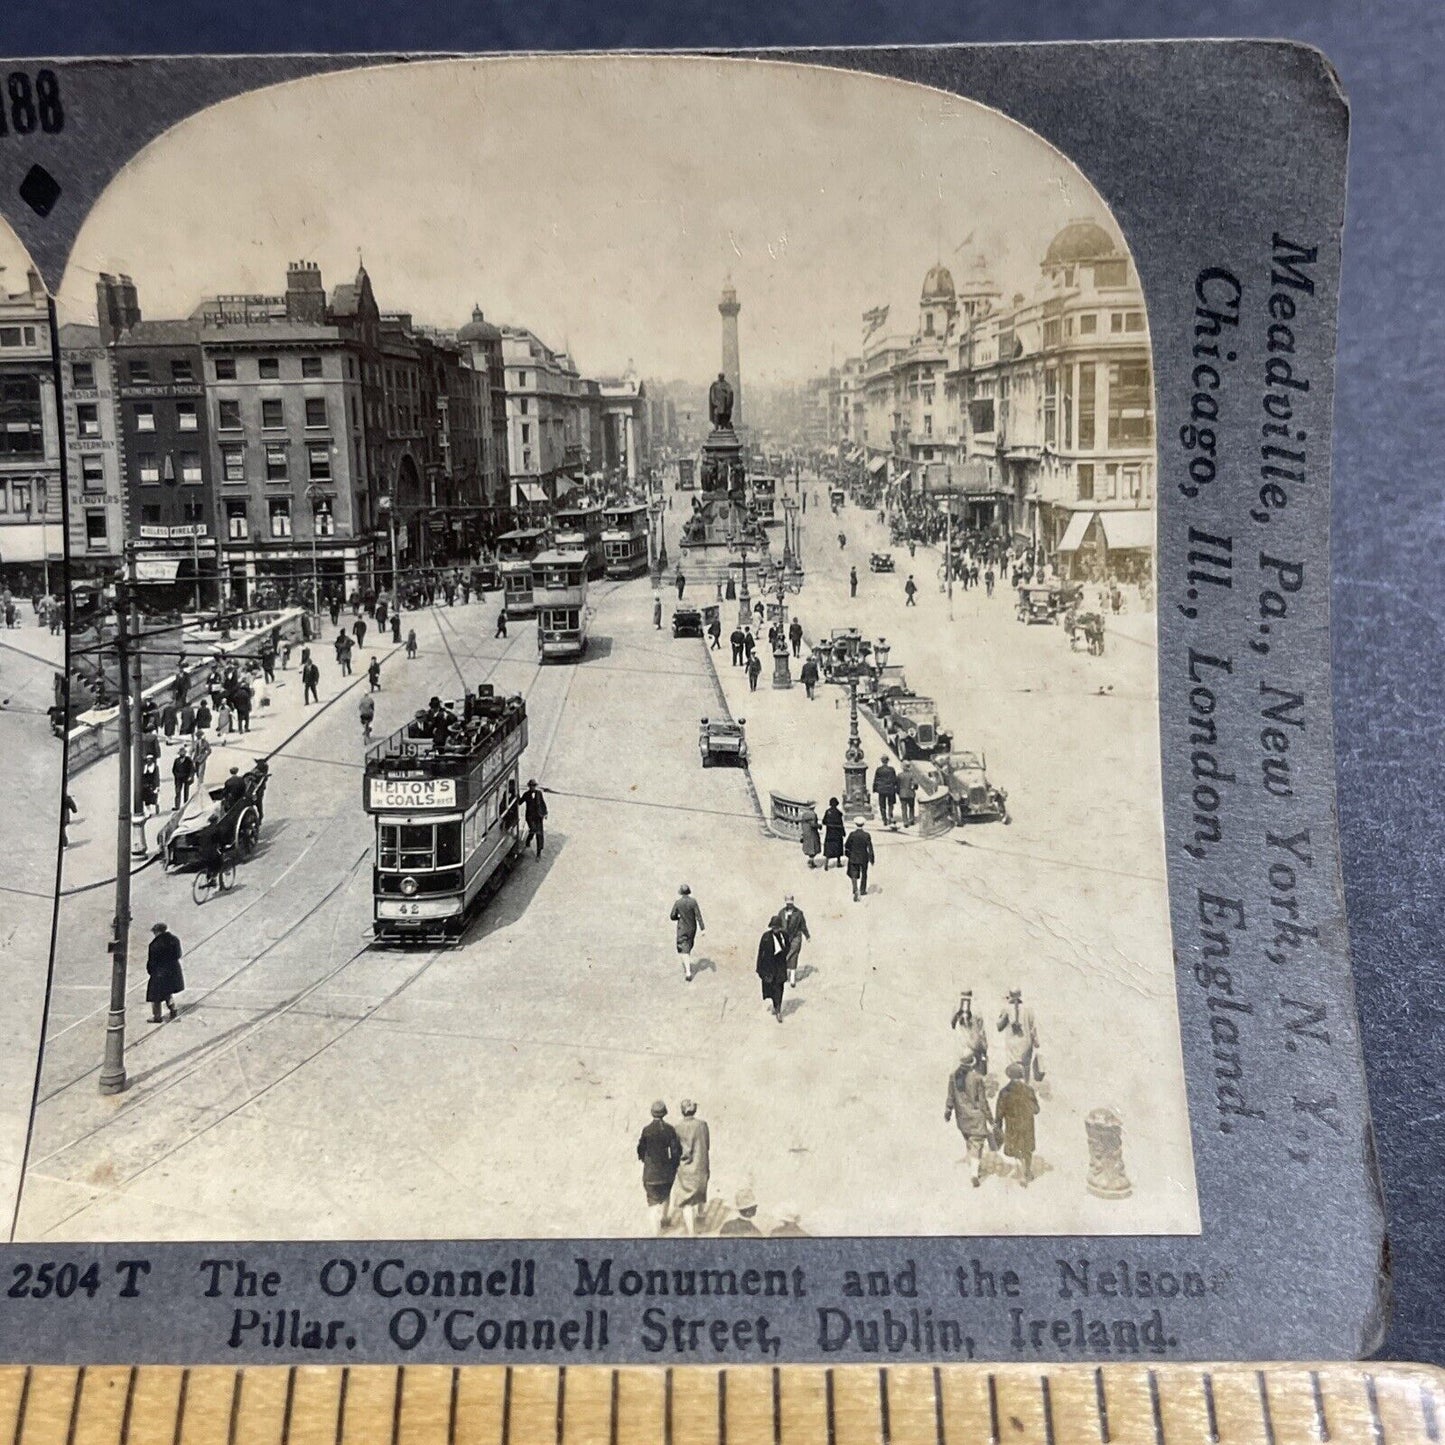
left=12, top=488, right=1198, bottom=1240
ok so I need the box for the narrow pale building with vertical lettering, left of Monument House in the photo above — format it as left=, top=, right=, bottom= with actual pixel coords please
left=61, top=324, right=126, bottom=577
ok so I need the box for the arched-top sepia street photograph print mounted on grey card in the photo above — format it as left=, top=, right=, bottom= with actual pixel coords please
left=8, top=56, right=1199, bottom=1241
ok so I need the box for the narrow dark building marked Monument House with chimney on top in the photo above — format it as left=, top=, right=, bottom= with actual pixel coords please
left=95, top=273, right=220, bottom=610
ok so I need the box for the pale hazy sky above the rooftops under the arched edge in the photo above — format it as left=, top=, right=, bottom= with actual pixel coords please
left=56, top=56, right=1117, bottom=384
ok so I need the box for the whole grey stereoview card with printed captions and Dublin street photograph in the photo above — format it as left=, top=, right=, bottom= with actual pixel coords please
left=0, top=42, right=1381, bottom=1358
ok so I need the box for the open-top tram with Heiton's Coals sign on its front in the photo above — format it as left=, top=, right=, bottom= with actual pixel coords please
left=363, top=683, right=527, bottom=939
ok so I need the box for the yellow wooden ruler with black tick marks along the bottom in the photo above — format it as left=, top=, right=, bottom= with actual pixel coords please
left=0, top=1364, right=1445, bottom=1445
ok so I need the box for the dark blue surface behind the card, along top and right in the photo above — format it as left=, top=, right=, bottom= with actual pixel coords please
left=0, top=0, right=1445, bottom=1363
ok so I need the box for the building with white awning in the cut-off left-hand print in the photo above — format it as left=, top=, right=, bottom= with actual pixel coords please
left=0, top=270, right=65, bottom=595
